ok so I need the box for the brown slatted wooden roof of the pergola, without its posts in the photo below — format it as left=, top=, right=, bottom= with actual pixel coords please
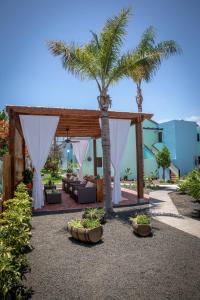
left=6, top=105, right=152, bottom=138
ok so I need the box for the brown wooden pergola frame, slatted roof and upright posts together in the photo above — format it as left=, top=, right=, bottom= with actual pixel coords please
left=5, top=105, right=152, bottom=203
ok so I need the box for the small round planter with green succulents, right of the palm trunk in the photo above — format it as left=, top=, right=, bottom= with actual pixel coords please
left=130, top=214, right=152, bottom=237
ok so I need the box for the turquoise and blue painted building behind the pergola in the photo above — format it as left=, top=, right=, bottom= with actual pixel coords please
left=61, top=120, right=200, bottom=179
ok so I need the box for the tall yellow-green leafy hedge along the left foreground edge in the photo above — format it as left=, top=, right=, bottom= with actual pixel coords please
left=0, top=184, right=32, bottom=300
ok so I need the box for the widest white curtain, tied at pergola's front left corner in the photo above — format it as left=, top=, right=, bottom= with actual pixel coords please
left=20, top=115, right=59, bottom=208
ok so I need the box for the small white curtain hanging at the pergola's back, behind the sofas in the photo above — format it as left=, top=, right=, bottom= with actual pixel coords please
left=73, top=140, right=88, bottom=180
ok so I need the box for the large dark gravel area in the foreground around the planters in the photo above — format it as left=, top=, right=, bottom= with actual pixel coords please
left=27, top=208, right=200, bottom=300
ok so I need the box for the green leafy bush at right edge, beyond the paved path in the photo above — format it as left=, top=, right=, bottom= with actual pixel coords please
left=179, top=168, right=200, bottom=200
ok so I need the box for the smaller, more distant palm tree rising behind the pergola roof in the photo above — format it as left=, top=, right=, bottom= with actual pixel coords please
left=126, top=26, right=181, bottom=112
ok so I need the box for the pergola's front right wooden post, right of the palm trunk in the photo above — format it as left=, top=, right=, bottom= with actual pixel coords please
left=135, top=117, right=144, bottom=203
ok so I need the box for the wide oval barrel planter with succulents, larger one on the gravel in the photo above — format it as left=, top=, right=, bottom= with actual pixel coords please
left=67, top=219, right=103, bottom=243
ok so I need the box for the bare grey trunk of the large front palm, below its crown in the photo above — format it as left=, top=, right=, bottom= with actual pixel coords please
left=101, top=111, right=113, bottom=215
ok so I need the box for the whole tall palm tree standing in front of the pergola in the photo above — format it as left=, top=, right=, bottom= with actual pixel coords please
left=49, top=9, right=134, bottom=214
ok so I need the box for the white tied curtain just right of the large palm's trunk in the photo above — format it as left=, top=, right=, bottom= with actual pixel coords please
left=109, top=119, right=131, bottom=204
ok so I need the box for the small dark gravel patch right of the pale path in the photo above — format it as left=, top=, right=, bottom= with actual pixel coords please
left=169, top=192, right=200, bottom=220
